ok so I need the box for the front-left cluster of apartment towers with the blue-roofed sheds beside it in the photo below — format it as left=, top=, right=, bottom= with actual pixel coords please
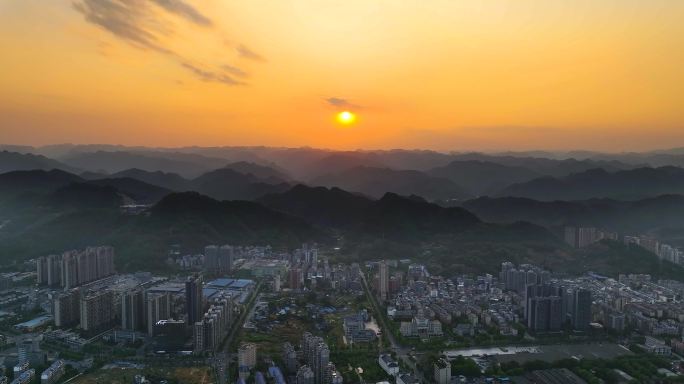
left=49, top=258, right=254, bottom=353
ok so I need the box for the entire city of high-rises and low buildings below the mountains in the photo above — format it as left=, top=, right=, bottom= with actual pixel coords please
left=0, top=237, right=684, bottom=384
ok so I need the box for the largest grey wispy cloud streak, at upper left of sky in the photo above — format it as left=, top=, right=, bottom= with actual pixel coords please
left=72, top=0, right=255, bottom=85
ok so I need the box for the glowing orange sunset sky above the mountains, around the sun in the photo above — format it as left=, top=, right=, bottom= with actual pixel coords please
left=0, top=0, right=684, bottom=151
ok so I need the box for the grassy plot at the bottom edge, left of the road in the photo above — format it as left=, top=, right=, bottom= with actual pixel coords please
left=72, top=367, right=216, bottom=384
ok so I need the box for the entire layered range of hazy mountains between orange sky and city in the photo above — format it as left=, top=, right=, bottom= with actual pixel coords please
left=0, top=145, right=684, bottom=280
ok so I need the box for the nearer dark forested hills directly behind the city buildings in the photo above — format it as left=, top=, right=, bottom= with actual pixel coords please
left=0, top=166, right=681, bottom=280
